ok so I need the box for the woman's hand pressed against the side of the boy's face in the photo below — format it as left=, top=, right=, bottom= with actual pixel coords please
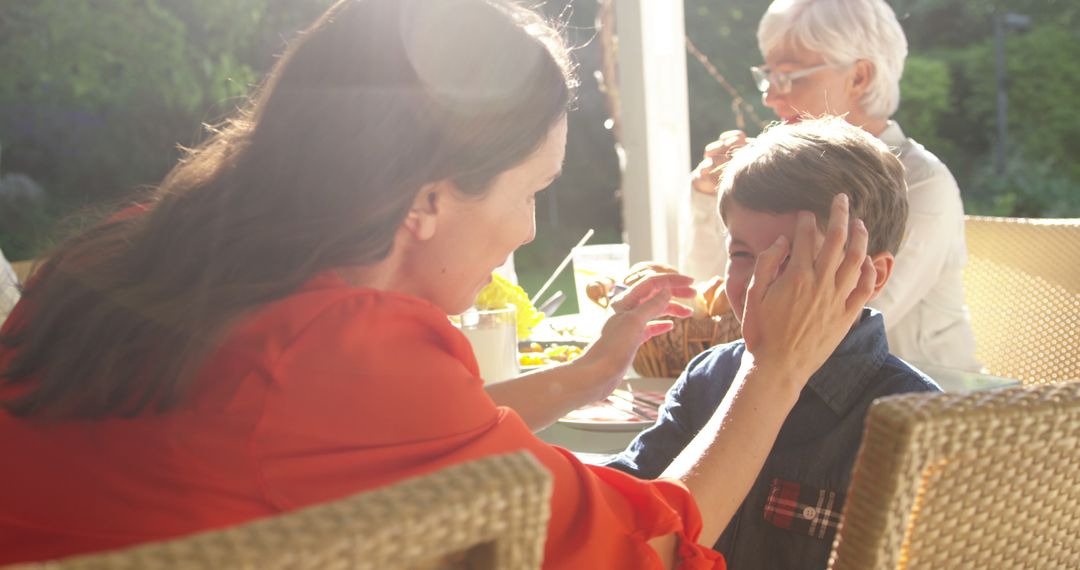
left=743, top=194, right=875, bottom=383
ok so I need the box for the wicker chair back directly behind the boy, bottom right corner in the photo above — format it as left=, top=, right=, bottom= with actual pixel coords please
left=829, top=382, right=1080, bottom=570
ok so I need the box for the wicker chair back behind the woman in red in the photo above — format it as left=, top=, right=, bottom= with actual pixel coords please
left=12, top=451, right=551, bottom=570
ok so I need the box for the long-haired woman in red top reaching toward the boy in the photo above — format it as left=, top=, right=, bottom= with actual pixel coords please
left=0, top=0, right=875, bottom=569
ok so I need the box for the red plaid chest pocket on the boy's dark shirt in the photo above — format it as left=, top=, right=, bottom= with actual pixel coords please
left=765, top=479, right=843, bottom=542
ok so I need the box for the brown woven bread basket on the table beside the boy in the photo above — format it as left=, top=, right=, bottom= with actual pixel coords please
left=634, top=311, right=742, bottom=378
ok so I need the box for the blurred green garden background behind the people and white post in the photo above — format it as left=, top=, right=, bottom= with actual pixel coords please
left=0, top=0, right=1080, bottom=313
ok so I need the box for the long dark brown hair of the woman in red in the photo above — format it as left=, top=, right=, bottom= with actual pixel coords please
left=0, top=0, right=575, bottom=420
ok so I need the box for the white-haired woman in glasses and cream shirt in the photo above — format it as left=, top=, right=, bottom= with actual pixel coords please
left=683, top=0, right=980, bottom=370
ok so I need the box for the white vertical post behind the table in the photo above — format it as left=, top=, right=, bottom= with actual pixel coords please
left=615, top=0, right=690, bottom=264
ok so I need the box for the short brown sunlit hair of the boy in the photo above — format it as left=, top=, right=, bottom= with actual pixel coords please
left=718, top=118, right=907, bottom=255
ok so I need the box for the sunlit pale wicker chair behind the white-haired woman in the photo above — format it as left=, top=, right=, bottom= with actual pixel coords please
left=963, top=216, right=1080, bottom=383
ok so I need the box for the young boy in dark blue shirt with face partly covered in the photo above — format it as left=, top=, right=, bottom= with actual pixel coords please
left=609, top=119, right=940, bottom=569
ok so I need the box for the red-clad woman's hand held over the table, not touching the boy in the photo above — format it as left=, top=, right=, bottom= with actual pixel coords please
left=579, top=273, right=697, bottom=397
